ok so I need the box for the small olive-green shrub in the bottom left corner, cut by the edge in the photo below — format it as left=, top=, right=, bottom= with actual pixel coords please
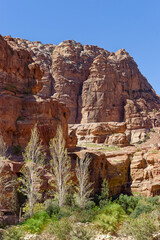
left=1, top=227, right=22, bottom=240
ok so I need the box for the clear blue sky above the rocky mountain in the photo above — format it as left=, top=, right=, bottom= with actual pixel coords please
left=0, top=0, right=160, bottom=94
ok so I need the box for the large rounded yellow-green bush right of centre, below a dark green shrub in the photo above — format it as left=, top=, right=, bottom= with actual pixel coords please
left=94, top=203, right=126, bottom=233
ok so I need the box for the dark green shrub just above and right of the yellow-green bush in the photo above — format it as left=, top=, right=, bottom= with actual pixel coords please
left=117, top=194, right=140, bottom=214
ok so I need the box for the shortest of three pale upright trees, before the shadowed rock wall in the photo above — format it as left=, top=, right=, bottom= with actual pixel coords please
left=76, top=155, right=93, bottom=208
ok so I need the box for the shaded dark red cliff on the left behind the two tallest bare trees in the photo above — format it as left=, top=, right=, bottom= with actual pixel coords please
left=0, top=36, right=69, bottom=147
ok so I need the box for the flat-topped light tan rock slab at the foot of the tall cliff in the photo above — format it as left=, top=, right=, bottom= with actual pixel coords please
left=69, top=122, right=129, bottom=147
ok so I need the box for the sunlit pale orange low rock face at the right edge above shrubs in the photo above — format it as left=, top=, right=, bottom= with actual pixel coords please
left=130, top=149, right=160, bottom=196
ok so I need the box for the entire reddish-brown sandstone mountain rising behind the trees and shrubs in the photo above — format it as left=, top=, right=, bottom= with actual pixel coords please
left=0, top=36, right=160, bottom=204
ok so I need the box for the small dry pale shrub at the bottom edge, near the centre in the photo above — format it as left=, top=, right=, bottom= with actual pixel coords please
left=70, top=225, right=92, bottom=240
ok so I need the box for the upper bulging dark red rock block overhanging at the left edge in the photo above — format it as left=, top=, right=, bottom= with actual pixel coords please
left=0, top=36, right=43, bottom=94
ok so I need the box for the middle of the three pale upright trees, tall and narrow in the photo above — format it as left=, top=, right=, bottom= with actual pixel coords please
left=50, top=126, right=71, bottom=207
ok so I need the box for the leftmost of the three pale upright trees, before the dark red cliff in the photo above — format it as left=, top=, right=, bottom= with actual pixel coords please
left=19, top=125, right=45, bottom=216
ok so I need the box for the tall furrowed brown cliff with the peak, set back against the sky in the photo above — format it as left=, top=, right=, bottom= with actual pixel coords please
left=2, top=37, right=160, bottom=123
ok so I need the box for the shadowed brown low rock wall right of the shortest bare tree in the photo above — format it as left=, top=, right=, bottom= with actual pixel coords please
left=75, top=150, right=130, bottom=196
